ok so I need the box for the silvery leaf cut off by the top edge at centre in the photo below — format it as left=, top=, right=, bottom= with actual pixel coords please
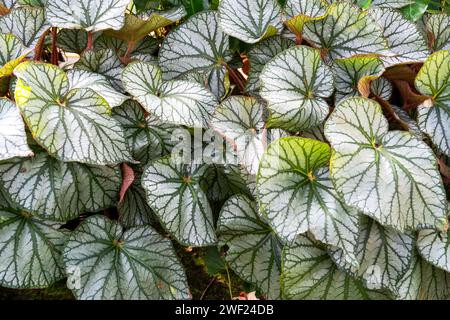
left=219, top=0, right=283, bottom=43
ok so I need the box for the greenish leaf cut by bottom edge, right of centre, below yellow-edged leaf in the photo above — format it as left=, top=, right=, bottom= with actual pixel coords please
left=281, top=235, right=386, bottom=300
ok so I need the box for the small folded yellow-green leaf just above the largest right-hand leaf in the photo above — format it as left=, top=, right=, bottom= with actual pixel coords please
left=333, top=57, right=385, bottom=103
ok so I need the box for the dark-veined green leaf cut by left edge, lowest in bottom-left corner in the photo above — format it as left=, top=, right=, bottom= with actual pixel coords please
left=0, top=188, right=66, bottom=289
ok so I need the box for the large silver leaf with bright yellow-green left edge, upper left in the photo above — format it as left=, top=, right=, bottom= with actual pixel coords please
left=14, top=62, right=131, bottom=165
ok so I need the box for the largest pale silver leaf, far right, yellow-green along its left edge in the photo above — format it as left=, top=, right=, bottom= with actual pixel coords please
left=325, top=98, right=447, bottom=231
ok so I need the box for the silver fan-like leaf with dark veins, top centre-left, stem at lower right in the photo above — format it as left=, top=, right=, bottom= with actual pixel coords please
left=159, top=11, right=232, bottom=81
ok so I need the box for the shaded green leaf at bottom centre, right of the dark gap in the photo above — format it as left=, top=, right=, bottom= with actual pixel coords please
left=217, top=195, right=282, bottom=299
